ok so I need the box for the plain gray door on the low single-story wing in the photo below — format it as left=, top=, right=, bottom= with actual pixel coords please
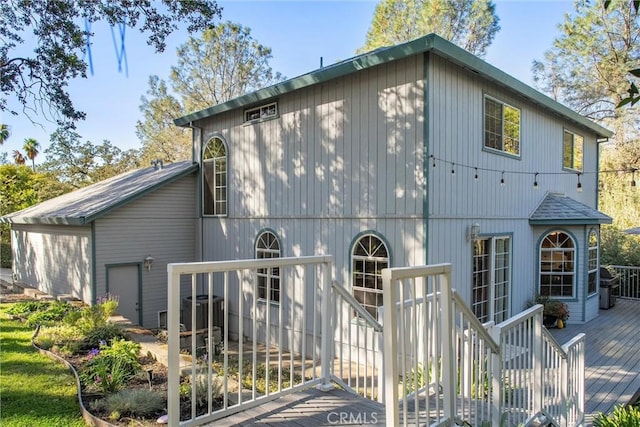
left=107, top=264, right=141, bottom=324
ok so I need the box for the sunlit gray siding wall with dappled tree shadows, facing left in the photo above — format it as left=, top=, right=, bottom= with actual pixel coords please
left=195, top=57, right=425, bottom=338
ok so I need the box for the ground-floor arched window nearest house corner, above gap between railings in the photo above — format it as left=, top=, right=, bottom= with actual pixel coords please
left=351, top=234, right=389, bottom=319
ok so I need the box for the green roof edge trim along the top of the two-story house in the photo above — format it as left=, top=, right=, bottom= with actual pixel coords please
left=174, top=34, right=613, bottom=138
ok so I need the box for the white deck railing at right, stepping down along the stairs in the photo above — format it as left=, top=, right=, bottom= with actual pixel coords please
left=382, top=264, right=584, bottom=426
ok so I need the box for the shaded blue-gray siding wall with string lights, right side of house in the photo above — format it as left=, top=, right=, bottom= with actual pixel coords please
left=427, top=55, right=598, bottom=322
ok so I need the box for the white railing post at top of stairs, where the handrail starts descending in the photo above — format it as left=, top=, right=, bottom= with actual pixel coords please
left=439, top=271, right=457, bottom=421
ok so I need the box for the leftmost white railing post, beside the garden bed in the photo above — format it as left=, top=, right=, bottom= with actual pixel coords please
left=167, top=264, right=180, bottom=426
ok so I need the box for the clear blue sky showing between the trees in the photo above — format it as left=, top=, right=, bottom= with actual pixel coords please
left=0, top=0, right=573, bottom=163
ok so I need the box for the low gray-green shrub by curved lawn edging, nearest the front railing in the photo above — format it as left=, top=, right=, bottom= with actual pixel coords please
left=90, top=389, right=166, bottom=421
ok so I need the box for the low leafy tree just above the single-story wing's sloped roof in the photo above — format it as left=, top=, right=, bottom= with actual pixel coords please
left=41, top=130, right=140, bottom=188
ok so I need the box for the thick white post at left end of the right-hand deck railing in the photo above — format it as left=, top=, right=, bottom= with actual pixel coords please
left=382, top=268, right=400, bottom=426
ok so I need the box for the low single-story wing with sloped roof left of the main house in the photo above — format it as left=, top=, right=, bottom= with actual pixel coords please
left=2, top=161, right=198, bottom=327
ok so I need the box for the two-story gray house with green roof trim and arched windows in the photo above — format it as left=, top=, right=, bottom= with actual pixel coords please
left=175, top=34, right=611, bottom=332
